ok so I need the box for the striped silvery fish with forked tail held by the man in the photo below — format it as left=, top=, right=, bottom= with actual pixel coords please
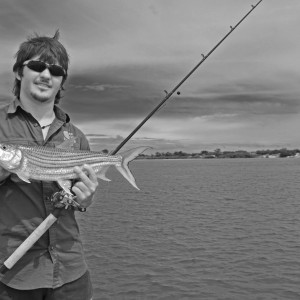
left=0, top=142, right=150, bottom=193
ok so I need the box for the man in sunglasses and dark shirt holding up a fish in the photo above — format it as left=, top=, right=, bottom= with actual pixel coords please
left=0, top=31, right=98, bottom=300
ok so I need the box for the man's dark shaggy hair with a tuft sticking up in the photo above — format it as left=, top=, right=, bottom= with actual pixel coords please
left=13, top=30, right=69, bottom=104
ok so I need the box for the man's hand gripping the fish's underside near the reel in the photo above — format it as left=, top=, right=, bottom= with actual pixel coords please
left=72, top=165, right=98, bottom=207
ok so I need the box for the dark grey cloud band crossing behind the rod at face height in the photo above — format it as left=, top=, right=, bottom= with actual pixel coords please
left=62, top=64, right=299, bottom=126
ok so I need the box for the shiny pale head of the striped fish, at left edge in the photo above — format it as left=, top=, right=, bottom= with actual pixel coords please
left=0, top=143, right=22, bottom=170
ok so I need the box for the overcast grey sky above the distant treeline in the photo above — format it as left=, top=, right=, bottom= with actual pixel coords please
left=0, top=0, right=300, bottom=152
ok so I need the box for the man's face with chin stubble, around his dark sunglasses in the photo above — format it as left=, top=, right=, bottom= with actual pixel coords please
left=19, top=56, right=63, bottom=102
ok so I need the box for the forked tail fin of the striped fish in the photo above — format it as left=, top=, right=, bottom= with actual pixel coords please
left=116, top=147, right=150, bottom=190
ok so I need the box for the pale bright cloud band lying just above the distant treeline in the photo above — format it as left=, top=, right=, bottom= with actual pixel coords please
left=81, top=109, right=300, bottom=152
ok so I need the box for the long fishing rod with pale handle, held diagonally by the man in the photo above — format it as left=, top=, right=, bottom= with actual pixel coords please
left=0, top=0, right=262, bottom=273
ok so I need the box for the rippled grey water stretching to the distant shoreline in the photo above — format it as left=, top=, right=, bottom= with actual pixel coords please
left=79, top=159, right=300, bottom=300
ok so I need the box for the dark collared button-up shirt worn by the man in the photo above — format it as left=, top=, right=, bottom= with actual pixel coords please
left=0, top=100, right=89, bottom=290
